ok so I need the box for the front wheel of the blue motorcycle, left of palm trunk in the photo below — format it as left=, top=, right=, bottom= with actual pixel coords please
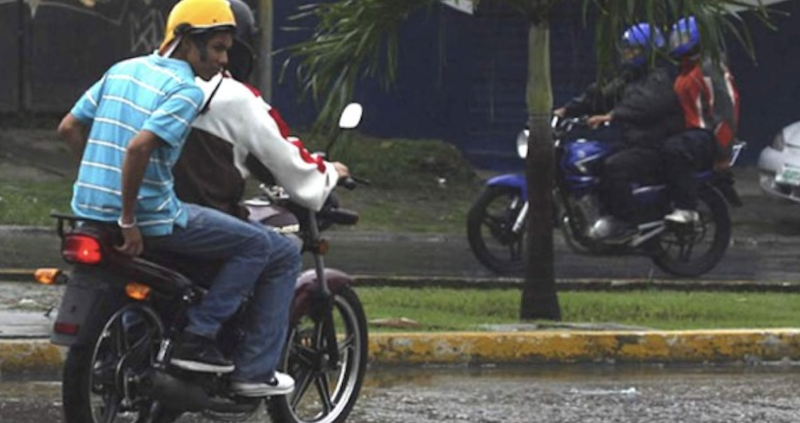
left=467, top=186, right=527, bottom=274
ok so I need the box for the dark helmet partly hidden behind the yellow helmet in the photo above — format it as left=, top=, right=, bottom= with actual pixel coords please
left=228, top=0, right=258, bottom=81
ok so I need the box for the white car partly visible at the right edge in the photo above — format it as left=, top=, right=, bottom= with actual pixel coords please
left=758, top=121, right=800, bottom=202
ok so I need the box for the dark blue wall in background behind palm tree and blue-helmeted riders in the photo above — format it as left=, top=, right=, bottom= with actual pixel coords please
left=273, top=1, right=800, bottom=169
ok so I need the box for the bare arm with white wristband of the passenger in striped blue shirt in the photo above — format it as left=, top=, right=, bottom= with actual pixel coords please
left=117, top=130, right=161, bottom=256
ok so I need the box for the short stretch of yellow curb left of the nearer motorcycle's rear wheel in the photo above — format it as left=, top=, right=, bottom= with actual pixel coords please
left=0, top=339, right=66, bottom=374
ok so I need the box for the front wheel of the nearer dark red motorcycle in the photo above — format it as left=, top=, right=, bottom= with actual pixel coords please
left=269, top=287, right=367, bottom=423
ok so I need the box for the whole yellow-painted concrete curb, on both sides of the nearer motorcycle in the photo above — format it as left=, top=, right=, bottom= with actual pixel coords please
left=0, top=329, right=800, bottom=375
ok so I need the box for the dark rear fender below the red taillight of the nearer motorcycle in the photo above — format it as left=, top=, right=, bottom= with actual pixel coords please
left=50, top=266, right=126, bottom=346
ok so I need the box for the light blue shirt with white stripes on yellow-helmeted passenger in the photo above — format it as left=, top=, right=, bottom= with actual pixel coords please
left=71, top=53, right=204, bottom=236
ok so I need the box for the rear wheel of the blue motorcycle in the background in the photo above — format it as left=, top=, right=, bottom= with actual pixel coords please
left=653, top=187, right=731, bottom=277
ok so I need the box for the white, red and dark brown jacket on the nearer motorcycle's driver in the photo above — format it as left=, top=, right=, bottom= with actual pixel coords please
left=173, top=75, right=339, bottom=218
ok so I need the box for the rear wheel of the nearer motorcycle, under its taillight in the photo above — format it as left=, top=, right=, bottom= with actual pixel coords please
left=62, top=304, right=166, bottom=423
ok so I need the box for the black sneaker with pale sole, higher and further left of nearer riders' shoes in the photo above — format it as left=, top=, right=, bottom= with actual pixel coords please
left=170, top=332, right=234, bottom=373
